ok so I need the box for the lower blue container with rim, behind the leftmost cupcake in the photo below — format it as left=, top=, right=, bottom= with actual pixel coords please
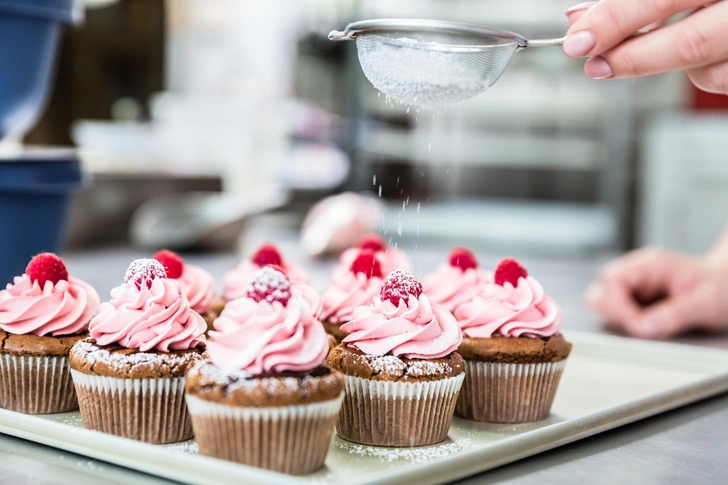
left=0, top=150, right=84, bottom=289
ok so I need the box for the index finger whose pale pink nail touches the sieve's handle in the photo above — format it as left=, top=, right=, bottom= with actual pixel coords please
left=564, top=0, right=706, bottom=57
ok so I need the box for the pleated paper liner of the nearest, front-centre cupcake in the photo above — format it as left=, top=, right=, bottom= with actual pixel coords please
left=187, top=395, right=343, bottom=475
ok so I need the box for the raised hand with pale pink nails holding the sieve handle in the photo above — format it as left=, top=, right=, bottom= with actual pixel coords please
left=564, top=0, right=728, bottom=94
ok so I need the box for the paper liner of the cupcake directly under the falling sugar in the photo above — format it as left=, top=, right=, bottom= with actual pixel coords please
left=336, top=374, right=465, bottom=446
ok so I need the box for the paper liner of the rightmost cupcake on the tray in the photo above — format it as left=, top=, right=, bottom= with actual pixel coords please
left=455, top=360, right=566, bottom=423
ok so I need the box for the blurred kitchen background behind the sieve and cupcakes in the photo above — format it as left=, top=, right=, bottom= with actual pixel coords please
left=0, top=0, right=728, bottom=284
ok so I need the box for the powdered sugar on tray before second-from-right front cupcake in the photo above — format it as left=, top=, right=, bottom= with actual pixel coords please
left=334, top=438, right=473, bottom=463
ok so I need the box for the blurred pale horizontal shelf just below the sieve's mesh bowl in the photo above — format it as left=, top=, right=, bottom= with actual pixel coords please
left=357, top=126, right=605, bottom=170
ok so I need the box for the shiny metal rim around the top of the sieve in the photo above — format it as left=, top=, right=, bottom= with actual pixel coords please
left=329, top=19, right=528, bottom=48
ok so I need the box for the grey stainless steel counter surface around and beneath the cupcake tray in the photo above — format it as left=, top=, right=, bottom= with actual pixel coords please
left=0, top=242, right=728, bottom=485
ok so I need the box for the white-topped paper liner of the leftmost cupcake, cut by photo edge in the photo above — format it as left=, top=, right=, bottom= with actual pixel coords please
left=0, top=354, right=78, bottom=414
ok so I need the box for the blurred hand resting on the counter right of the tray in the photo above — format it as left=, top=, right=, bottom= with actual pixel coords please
left=585, top=248, right=728, bottom=338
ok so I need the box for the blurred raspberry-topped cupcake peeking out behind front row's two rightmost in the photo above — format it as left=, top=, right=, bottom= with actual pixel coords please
left=422, top=248, right=493, bottom=312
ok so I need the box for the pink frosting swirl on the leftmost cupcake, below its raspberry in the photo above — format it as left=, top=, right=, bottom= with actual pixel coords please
left=0, top=274, right=100, bottom=336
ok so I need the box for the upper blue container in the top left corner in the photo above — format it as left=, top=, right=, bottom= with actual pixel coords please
left=0, top=0, right=76, bottom=139
